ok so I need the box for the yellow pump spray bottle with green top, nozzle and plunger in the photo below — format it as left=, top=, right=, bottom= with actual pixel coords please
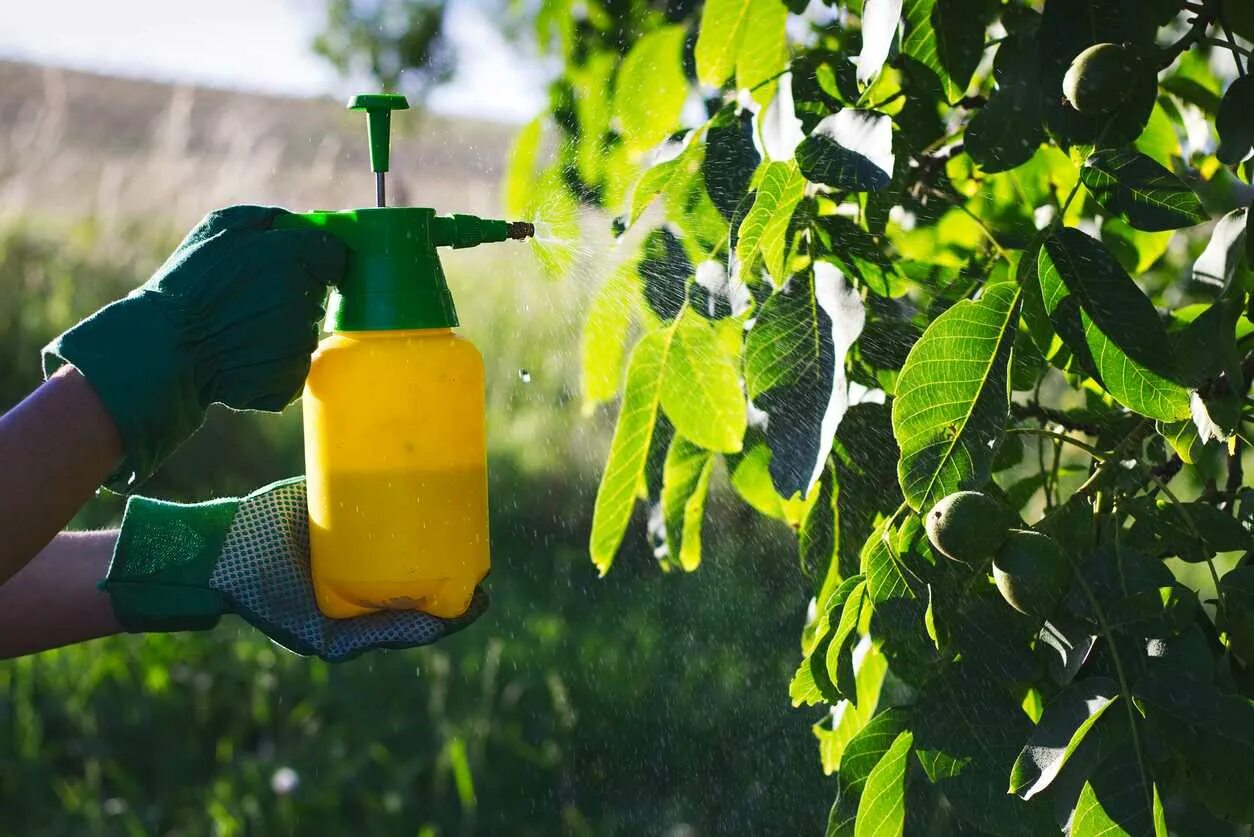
left=283, top=94, right=534, bottom=619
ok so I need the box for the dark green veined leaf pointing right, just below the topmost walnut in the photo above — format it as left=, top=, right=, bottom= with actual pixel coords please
left=1080, top=148, right=1206, bottom=232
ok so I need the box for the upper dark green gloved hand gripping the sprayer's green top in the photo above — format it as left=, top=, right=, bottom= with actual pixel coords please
left=44, top=206, right=346, bottom=492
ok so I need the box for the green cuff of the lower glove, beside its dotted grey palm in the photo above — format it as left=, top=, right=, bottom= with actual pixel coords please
left=100, top=497, right=240, bottom=634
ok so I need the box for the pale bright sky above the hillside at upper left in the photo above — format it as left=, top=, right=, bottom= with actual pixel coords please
left=0, top=0, right=547, bottom=122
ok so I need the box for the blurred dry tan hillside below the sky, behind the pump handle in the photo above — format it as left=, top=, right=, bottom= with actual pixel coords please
left=0, top=61, right=515, bottom=227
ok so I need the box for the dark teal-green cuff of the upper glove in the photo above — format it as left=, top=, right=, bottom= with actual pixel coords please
left=44, top=292, right=204, bottom=494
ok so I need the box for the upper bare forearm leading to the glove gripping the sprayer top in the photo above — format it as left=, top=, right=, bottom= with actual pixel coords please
left=0, top=366, right=122, bottom=584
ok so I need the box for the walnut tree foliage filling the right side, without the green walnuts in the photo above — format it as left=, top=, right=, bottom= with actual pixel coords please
left=494, top=0, right=1254, bottom=836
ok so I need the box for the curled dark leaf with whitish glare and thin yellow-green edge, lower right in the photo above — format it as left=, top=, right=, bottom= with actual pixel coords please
left=1009, top=678, right=1119, bottom=799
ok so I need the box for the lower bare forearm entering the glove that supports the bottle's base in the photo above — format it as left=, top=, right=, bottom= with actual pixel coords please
left=0, top=531, right=122, bottom=659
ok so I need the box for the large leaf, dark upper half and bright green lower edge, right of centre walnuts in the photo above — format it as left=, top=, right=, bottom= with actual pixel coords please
left=1037, top=228, right=1189, bottom=422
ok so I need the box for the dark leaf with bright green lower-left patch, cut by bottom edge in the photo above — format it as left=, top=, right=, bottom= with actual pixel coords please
left=1071, top=742, right=1167, bottom=837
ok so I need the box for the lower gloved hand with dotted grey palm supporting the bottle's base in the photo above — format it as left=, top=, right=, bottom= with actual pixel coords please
left=100, top=477, right=488, bottom=663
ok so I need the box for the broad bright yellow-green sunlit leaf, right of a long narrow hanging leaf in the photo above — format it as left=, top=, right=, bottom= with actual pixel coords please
left=661, top=309, right=746, bottom=453
